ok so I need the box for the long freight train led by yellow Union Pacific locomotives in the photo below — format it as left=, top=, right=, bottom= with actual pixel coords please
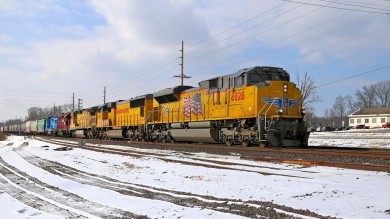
left=1, top=66, right=310, bottom=147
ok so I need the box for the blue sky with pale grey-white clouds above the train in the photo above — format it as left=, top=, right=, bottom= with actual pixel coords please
left=0, top=0, right=390, bottom=121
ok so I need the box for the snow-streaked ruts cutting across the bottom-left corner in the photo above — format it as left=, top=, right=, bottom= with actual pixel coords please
left=0, top=157, right=140, bottom=218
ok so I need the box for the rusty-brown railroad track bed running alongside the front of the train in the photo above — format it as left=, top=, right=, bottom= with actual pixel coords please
left=39, top=138, right=390, bottom=174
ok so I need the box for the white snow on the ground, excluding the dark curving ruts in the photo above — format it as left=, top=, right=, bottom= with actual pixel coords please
left=0, top=133, right=390, bottom=219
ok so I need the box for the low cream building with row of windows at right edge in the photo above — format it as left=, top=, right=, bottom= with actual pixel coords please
left=348, top=107, right=390, bottom=128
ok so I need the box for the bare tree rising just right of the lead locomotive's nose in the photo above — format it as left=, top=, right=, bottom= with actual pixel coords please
left=296, top=71, right=321, bottom=110
